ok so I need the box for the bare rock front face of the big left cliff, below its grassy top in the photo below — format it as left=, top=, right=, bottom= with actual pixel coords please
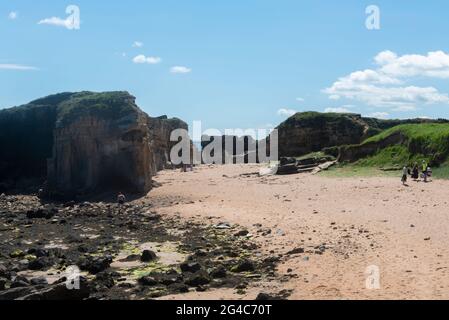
left=48, top=112, right=152, bottom=193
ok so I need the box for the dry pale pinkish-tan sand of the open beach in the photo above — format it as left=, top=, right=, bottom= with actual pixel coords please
left=148, top=165, right=449, bottom=299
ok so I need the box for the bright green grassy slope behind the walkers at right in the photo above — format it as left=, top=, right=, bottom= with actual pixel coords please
left=328, top=123, right=449, bottom=178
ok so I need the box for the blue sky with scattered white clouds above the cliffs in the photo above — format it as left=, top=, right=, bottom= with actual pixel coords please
left=0, top=0, right=449, bottom=130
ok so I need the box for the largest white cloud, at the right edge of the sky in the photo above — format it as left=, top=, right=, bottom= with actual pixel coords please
left=323, top=51, right=449, bottom=111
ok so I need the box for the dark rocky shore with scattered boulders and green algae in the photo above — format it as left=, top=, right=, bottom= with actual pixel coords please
left=0, top=194, right=279, bottom=300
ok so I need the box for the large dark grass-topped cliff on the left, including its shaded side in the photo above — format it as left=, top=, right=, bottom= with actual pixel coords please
left=0, top=92, right=187, bottom=195
